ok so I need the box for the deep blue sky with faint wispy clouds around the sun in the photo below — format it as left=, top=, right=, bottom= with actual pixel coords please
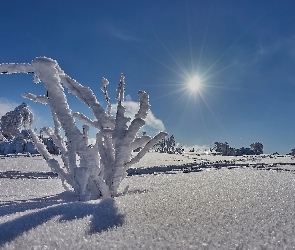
left=0, top=0, right=295, bottom=153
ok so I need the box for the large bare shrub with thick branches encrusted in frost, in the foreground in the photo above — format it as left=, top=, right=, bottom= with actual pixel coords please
left=0, top=57, right=167, bottom=200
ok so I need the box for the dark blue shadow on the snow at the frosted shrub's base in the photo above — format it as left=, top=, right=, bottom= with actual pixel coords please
left=0, top=195, right=124, bottom=246
